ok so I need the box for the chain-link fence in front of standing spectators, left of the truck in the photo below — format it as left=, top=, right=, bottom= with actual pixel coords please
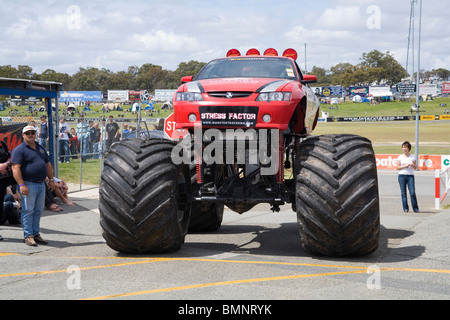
left=0, top=114, right=164, bottom=192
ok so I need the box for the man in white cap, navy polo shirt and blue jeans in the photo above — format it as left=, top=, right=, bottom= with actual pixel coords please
left=11, top=126, right=55, bottom=246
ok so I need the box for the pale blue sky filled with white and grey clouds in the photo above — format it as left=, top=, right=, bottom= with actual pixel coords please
left=0, top=0, right=450, bottom=75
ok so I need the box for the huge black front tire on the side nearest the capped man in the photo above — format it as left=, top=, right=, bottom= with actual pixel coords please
left=99, top=139, right=190, bottom=253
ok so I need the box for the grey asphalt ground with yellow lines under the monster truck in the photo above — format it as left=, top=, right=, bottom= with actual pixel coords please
left=0, top=171, right=450, bottom=304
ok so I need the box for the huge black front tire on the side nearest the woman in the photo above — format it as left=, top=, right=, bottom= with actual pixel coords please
left=296, top=135, right=380, bottom=257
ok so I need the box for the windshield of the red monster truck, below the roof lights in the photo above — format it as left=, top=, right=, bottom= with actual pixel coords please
left=195, top=57, right=298, bottom=80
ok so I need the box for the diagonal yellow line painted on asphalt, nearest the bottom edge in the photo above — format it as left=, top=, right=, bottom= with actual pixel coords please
left=82, top=270, right=366, bottom=300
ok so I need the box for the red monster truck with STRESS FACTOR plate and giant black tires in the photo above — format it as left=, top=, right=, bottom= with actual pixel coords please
left=99, top=49, right=380, bottom=256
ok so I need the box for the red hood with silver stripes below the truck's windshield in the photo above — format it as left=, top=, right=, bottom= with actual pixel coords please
left=185, top=78, right=292, bottom=93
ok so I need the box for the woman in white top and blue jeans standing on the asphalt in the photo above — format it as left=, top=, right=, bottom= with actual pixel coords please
left=397, top=141, right=419, bottom=213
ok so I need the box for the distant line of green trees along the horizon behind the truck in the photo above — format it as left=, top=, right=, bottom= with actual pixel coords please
left=0, top=50, right=450, bottom=92
